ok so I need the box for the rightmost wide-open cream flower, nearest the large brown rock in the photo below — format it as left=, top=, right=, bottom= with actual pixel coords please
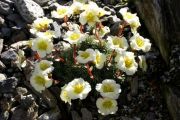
left=130, top=33, right=151, bottom=52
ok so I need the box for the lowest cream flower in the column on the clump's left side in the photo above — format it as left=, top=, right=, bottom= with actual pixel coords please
left=30, top=71, right=52, bottom=92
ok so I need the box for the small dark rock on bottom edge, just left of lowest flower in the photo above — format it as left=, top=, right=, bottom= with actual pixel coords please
left=81, top=108, right=93, bottom=120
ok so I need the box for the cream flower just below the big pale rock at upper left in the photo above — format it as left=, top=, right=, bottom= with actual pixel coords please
left=30, top=17, right=53, bottom=34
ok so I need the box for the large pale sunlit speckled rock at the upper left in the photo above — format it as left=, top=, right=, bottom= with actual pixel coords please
left=14, top=0, right=44, bottom=23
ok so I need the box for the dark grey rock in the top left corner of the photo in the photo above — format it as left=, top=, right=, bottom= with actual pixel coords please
left=0, top=1, right=12, bottom=15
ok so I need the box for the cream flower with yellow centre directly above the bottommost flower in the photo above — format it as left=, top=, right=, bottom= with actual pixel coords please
left=96, top=79, right=121, bottom=99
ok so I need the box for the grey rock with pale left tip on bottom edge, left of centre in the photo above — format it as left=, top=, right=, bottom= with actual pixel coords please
left=38, top=109, right=61, bottom=120
